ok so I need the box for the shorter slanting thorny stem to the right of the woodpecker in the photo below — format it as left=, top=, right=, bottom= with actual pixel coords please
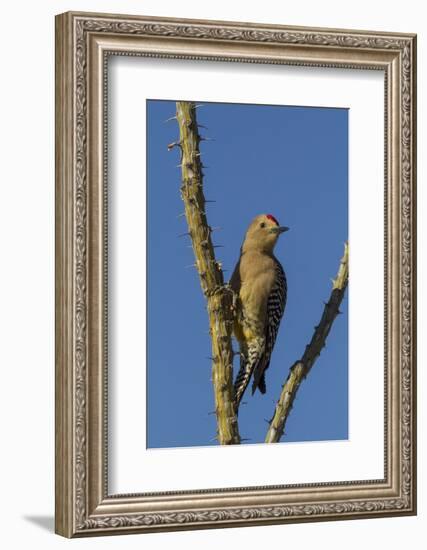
left=265, top=243, right=348, bottom=443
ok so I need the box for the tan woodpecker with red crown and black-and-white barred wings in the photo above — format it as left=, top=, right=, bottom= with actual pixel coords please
left=230, top=214, right=288, bottom=405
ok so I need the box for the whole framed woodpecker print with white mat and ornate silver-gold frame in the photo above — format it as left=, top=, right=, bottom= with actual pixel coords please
left=56, top=12, right=416, bottom=537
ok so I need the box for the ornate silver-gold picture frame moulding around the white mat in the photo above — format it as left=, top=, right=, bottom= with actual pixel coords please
left=56, top=13, right=416, bottom=537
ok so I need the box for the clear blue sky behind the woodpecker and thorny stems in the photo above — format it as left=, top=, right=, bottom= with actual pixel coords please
left=147, top=98, right=348, bottom=447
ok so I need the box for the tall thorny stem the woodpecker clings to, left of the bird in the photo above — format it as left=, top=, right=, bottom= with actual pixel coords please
left=175, top=101, right=240, bottom=445
